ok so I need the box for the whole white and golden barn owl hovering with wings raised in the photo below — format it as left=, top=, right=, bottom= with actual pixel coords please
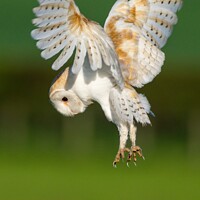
left=31, top=0, right=182, bottom=166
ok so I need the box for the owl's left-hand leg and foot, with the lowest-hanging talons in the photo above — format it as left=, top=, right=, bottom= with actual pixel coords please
left=113, top=125, right=130, bottom=167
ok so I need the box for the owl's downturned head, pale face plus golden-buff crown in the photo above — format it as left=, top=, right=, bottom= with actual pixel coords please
left=49, top=68, right=86, bottom=116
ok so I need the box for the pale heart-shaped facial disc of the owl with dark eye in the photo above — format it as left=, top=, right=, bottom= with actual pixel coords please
left=50, top=89, right=86, bottom=116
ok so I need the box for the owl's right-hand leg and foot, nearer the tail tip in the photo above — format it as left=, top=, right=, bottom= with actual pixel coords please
left=127, top=124, right=144, bottom=165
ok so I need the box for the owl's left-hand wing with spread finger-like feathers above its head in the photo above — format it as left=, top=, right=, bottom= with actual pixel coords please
left=31, top=0, right=123, bottom=86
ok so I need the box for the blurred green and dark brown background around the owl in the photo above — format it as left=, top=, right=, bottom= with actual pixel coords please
left=0, top=0, right=200, bottom=200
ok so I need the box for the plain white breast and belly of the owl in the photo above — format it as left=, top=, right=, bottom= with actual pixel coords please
left=66, top=62, right=114, bottom=121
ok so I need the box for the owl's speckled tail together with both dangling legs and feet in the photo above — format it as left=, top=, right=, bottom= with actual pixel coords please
left=110, top=88, right=151, bottom=166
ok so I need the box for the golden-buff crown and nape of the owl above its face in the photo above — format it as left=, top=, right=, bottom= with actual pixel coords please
left=49, top=67, right=69, bottom=97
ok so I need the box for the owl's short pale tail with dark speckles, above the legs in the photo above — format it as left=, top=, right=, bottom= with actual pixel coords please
left=110, top=88, right=153, bottom=125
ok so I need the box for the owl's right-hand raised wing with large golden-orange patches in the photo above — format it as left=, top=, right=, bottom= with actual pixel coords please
left=105, top=0, right=182, bottom=87
